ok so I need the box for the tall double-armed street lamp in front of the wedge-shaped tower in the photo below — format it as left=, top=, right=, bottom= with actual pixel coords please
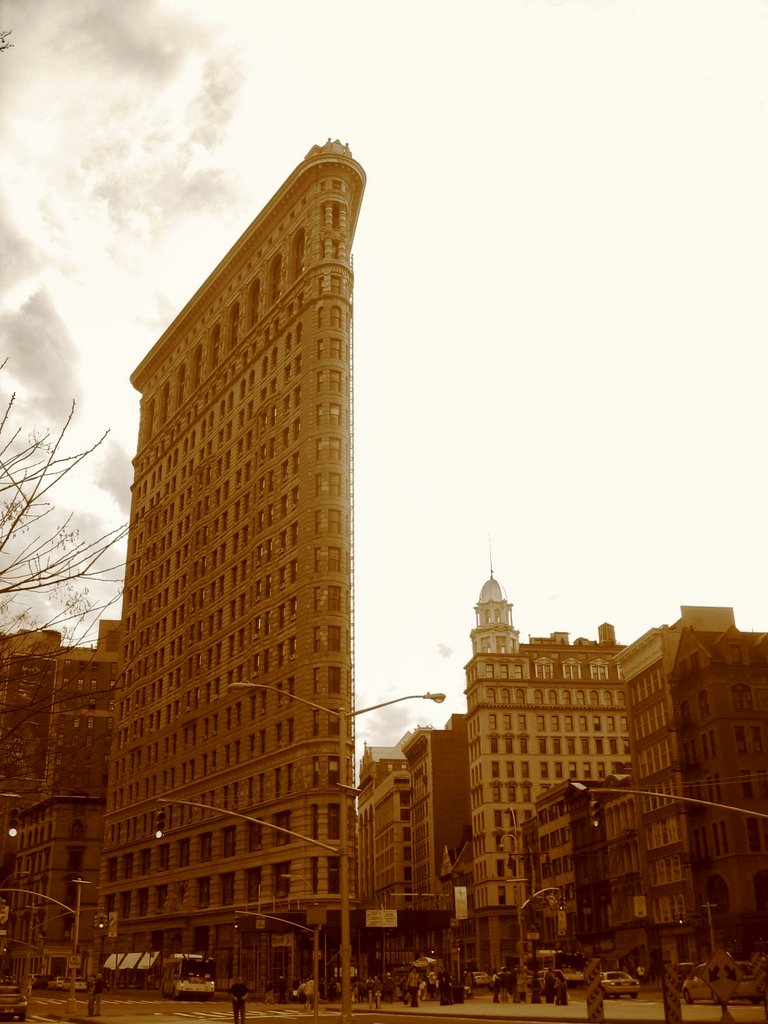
left=229, top=682, right=445, bottom=1024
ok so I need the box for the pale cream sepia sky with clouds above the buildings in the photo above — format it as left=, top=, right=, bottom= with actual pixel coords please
left=0, top=0, right=768, bottom=744
